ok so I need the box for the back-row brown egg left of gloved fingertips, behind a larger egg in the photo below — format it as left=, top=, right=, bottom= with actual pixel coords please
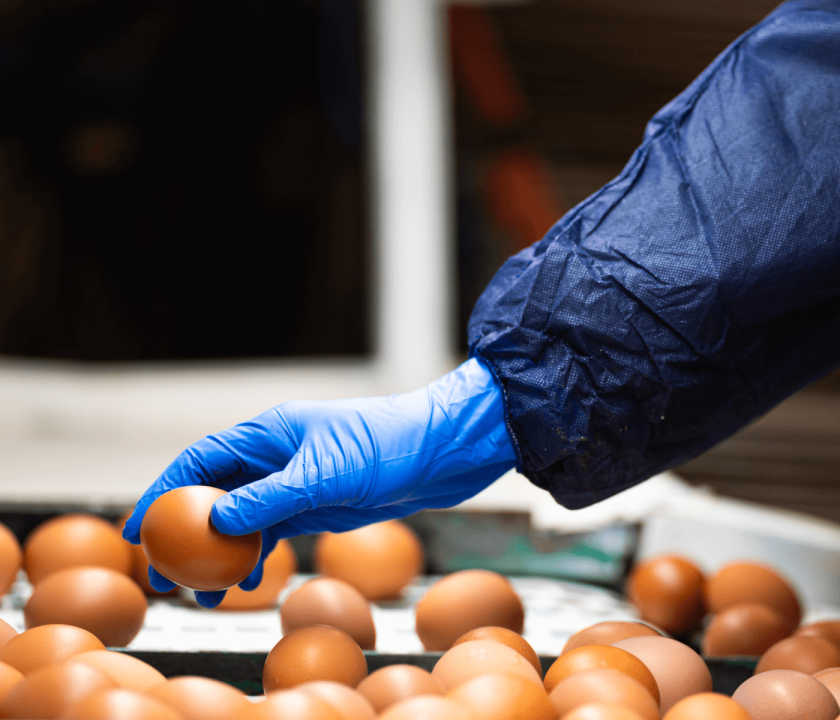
left=23, top=515, right=133, bottom=585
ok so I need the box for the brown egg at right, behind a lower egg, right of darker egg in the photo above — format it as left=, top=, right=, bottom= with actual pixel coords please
left=704, top=562, right=802, bottom=632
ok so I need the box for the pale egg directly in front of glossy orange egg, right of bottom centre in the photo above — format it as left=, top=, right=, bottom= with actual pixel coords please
left=549, top=668, right=659, bottom=720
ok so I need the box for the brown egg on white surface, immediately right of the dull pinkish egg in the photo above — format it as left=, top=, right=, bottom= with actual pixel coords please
left=416, top=570, right=525, bottom=650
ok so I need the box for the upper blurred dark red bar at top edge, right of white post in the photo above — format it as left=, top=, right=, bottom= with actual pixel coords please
left=449, top=5, right=527, bottom=127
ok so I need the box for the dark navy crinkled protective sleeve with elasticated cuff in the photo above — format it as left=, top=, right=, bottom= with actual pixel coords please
left=468, top=0, right=840, bottom=508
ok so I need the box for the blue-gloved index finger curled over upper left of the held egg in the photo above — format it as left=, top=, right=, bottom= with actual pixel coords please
left=123, top=420, right=297, bottom=545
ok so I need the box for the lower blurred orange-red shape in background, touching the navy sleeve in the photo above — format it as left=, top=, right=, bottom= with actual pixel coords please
left=485, top=149, right=566, bottom=253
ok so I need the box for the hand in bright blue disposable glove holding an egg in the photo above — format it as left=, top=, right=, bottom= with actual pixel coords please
left=123, top=359, right=516, bottom=607
